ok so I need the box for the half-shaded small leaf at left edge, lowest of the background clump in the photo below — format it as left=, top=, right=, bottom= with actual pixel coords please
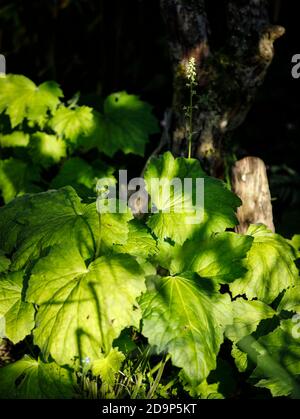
left=0, top=157, right=40, bottom=203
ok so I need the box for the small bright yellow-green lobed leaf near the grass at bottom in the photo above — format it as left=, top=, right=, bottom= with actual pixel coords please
left=92, top=348, right=125, bottom=387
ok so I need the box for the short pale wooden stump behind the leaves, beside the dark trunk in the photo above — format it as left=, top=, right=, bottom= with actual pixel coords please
left=232, top=157, right=275, bottom=234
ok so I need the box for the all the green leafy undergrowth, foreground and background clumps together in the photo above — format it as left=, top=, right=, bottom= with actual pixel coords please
left=0, top=76, right=300, bottom=398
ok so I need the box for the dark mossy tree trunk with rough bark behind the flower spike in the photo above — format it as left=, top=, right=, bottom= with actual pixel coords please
left=161, top=0, right=284, bottom=177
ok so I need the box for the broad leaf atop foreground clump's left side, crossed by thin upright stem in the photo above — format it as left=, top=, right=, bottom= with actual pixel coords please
left=0, top=187, right=132, bottom=269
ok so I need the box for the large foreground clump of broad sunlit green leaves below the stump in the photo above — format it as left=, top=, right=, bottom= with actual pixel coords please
left=0, top=148, right=300, bottom=398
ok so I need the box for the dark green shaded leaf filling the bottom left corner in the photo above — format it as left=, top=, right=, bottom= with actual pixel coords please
left=0, top=355, right=76, bottom=399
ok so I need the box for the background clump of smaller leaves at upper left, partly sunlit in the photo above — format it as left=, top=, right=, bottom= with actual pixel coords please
left=0, top=75, right=158, bottom=203
